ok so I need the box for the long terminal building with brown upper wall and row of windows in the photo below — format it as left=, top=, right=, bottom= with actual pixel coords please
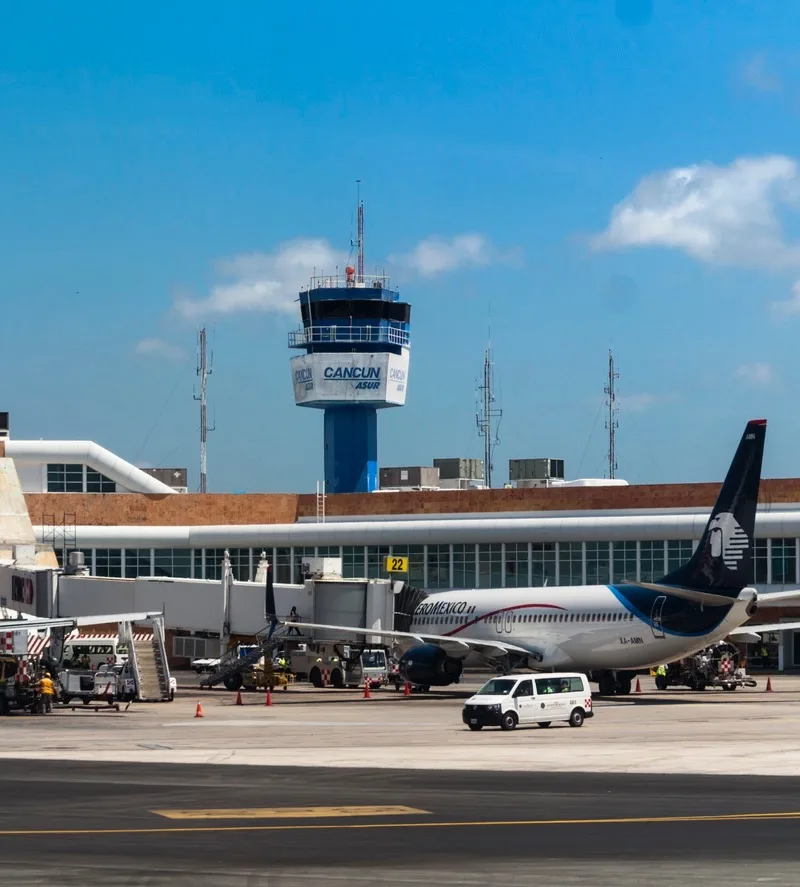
left=0, top=426, right=800, bottom=668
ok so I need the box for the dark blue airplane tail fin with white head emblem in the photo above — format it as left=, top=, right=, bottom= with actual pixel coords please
left=658, top=419, right=767, bottom=598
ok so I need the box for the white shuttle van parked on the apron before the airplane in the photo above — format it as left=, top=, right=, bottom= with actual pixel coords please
left=462, top=673, right=594, bottom=730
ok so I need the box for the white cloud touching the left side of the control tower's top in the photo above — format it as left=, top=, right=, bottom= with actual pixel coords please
left=175, top=239, right=347, bottom=320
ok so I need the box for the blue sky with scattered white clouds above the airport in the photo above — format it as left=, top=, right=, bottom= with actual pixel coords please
left=0, top=0, right=800, bottom=491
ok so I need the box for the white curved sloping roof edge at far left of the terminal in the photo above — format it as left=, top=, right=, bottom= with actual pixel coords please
left=5, top=440, right=177, bottom=495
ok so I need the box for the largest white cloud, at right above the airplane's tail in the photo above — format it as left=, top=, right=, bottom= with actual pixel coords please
left=593, top=155, right=800, bottom=267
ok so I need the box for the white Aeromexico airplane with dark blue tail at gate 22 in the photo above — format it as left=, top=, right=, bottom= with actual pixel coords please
left=286, top=419, right=800, bottom=696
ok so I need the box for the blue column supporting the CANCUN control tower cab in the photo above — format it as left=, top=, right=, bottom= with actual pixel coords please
left=325, top=406, right=378, bottom=493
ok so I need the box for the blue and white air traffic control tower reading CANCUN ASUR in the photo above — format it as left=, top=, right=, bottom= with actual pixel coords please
left=289, top=203, right=411, bottom=493
